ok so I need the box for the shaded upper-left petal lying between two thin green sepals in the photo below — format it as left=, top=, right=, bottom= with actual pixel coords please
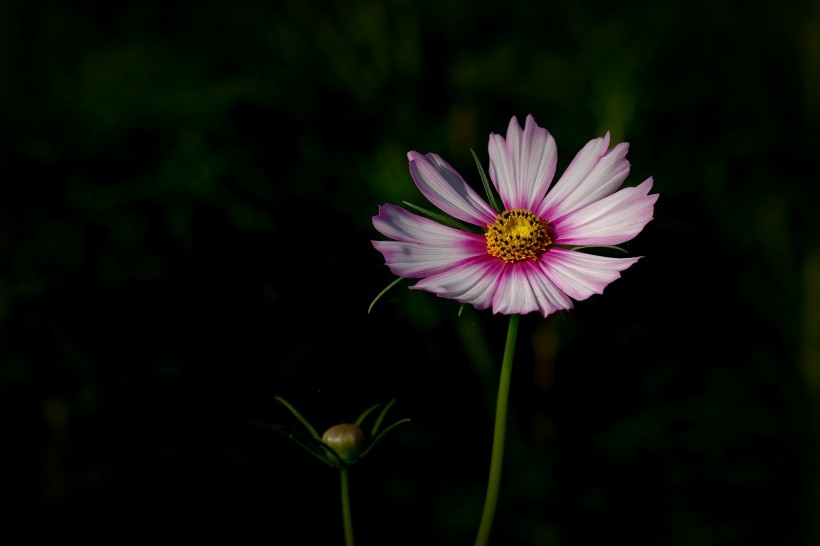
left=407, top=151, right=497, bottom=227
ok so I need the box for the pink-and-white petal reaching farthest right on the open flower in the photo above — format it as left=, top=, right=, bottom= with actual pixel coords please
left=552, top=178, right=658, bottom=246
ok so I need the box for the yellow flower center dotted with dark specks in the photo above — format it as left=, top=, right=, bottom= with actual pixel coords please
left=484, top=209, right=552, bottom=263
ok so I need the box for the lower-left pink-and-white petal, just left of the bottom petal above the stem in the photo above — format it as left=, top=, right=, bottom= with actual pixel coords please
left=411, top=254, right=504, bottom=310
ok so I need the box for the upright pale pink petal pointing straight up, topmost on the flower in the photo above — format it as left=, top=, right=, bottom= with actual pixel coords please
left=488, top=115, right=558, bottom=210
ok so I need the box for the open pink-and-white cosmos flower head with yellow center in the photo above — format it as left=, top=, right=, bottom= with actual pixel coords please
left=373, top=115, right=658, bottom=317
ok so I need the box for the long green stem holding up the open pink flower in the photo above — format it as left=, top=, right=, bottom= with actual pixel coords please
left=475, top=315, right=519, bottom=546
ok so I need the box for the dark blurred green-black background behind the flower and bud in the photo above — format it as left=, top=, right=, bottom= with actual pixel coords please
left=0, top=0, right=820, bottom=546
